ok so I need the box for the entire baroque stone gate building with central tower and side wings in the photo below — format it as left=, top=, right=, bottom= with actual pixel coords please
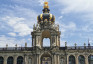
left=0, top=2, right=93, bottom=64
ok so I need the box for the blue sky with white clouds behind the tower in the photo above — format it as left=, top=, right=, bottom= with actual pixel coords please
left=0, top=0, right=93, bottom=47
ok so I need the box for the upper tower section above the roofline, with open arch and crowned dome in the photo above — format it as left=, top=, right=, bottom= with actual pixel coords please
left=31, top=2, right=60, bottom=49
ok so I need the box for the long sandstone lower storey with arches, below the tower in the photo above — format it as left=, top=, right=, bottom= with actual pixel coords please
left=0, top=47, right=93, bottom=64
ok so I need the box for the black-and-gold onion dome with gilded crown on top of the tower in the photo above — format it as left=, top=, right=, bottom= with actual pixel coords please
left=37, top=2, right=55, bottom=24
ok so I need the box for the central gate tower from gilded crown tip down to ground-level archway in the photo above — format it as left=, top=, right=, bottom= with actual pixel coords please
left=31, top=2, right=60, bottom=64
